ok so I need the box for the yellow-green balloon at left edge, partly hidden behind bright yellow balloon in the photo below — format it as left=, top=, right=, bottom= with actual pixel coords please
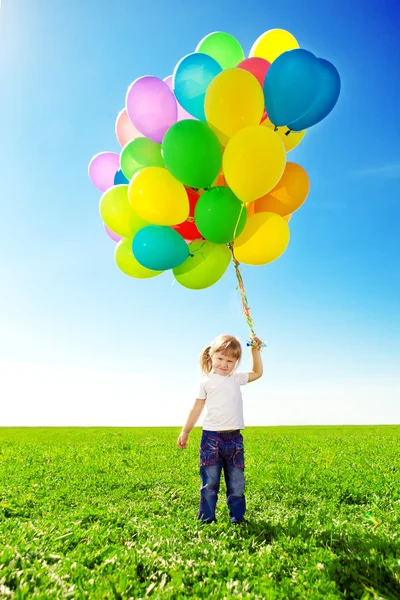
left=99, top=185, right=148, bottom=237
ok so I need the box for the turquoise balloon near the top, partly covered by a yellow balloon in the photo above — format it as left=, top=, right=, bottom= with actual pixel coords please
left=172, top=52, right=222, bottom=122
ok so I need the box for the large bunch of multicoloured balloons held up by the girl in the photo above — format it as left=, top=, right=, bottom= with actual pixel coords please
left=89, top=29, right=340, bottom=289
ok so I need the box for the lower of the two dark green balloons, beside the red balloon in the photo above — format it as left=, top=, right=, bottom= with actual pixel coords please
left=194, top=186, right=247, bottom=244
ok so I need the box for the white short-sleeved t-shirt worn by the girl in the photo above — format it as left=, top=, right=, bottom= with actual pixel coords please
left=197, top=371, right=249, bottom=431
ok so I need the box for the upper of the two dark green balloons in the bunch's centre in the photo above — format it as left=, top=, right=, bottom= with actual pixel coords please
left=162, top=120, right=222, bottom=188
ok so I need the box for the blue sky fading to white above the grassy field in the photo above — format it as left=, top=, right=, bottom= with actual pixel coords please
left=0, top=0, right=400, bottom=425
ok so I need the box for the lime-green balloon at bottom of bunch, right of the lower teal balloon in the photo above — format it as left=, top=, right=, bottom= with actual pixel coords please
left=172, top=240, right=232, bottom=290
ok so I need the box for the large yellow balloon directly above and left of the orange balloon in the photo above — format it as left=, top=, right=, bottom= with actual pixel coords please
left=222, top=125, right=286, bottom=202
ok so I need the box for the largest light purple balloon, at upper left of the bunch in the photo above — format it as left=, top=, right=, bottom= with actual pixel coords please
left=126, top=75, right=178, bottom=144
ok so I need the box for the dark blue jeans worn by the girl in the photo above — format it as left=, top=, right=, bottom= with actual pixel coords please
left=198, top=430, right=246, bottom=523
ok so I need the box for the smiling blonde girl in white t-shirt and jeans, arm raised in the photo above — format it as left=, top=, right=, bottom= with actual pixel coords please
left=178, top=335, right=263, bottom=523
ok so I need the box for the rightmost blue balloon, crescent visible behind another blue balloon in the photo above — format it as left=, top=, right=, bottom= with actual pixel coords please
left=288, top=58, right=340, bottom=131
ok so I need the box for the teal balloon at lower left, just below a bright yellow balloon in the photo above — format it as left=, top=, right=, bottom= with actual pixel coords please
left=132, top=225, right=189, bottom=271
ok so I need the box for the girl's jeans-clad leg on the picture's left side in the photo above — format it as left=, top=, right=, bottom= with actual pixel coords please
left=198, top=432, right=222, bottom=523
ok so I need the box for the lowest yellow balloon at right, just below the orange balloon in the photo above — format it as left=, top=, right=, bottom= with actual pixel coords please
left=234, top=212, right=290, bottom=265
